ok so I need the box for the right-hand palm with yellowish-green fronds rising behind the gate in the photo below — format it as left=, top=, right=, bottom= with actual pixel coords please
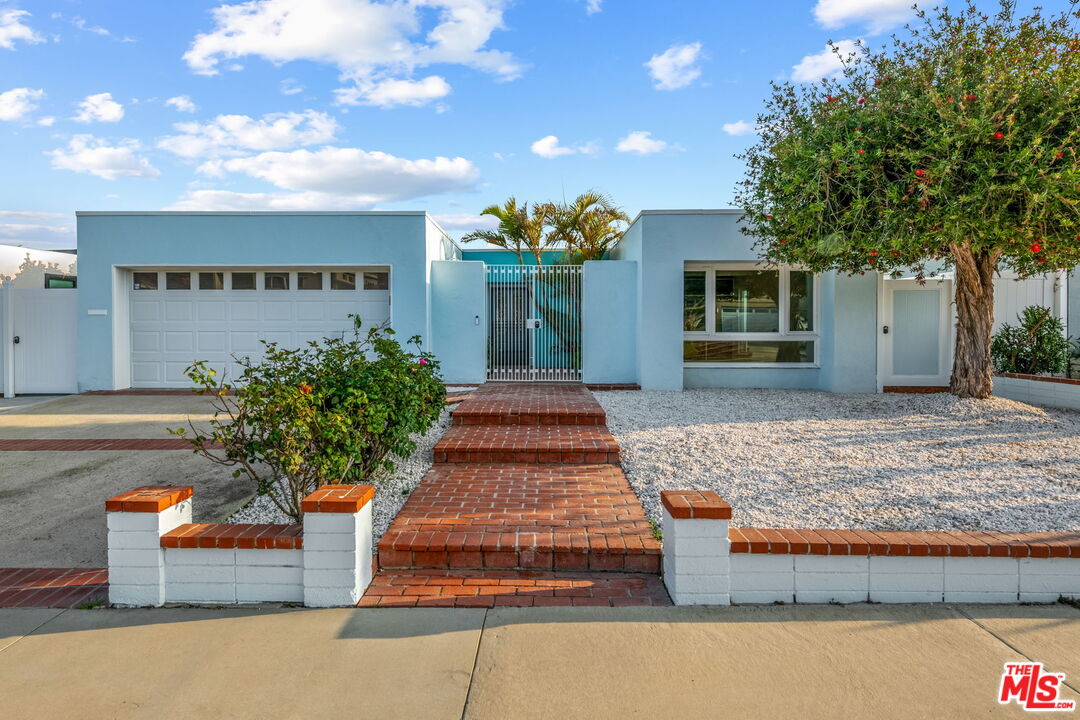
left=552, top=190, right=630, bottom=264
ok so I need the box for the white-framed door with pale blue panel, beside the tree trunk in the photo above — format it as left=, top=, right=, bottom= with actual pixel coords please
left=878, top=280, right=953, bottom=386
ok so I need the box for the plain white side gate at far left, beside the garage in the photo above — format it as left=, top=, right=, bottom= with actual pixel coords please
left=8, top=288, right=78, bottom=395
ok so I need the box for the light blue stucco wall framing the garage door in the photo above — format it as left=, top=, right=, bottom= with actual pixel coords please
left=78, top=213, right=433, bottom=391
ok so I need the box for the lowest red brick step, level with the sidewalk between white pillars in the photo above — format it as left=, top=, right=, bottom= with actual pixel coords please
left=359, top=570, right=671, bottom=608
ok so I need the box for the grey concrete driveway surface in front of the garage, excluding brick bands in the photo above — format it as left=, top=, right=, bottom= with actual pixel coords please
left=0, top=395, right=254, bottom=568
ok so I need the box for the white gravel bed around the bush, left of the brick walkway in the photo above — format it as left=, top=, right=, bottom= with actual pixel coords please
left=227, top=399, right=464, bottom=552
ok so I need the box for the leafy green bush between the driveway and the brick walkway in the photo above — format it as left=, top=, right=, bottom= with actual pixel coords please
left=170, top=317, right=446, bottom=521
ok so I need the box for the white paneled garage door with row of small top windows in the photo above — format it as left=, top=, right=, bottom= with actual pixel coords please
left=130, top=268, right=390, bottom=388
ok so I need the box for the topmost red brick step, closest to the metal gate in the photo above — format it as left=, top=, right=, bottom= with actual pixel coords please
left=454, top=383, right=606, bottom=425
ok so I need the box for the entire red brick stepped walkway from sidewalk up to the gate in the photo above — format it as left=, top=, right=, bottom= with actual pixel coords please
left=362, top=383, right=667, bottom=607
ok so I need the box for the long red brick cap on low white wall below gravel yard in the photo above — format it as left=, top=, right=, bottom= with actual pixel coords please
left=728, top=528, right=1080, bottom=558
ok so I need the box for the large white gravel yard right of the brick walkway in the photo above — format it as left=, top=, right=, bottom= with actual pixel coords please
left=594, top=389, right=1080, bottom=532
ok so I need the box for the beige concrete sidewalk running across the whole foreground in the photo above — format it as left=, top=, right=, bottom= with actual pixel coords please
left=0, top=604, right=1080, bottom=720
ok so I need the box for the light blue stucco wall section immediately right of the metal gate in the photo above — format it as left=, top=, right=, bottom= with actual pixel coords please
left=581, top=260, right=638, bottom=383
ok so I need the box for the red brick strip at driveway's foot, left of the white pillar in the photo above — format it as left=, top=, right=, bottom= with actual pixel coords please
left=0, top=568, right=109, bottom=608
